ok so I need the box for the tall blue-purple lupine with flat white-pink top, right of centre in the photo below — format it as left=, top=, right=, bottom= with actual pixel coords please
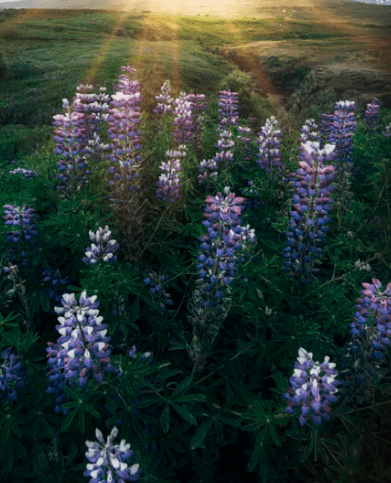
left=284, top=141, right=334, bottom=283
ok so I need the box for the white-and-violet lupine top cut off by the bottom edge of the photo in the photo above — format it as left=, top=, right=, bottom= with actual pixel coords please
left=83, top=426, right=142, bottom=483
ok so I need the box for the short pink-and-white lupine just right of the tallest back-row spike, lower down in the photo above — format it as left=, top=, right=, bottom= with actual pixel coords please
left=156, top=145, right=186, bottom=203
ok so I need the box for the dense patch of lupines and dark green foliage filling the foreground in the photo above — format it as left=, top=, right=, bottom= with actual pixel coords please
left=0, top=61, right=391, bottom=482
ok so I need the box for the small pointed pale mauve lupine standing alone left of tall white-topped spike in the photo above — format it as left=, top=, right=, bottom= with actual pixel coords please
left=257, top=116, right=283, bottom=173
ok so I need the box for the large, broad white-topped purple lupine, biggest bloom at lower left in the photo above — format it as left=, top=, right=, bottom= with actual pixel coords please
left=46, top=290, right=116, bottom=414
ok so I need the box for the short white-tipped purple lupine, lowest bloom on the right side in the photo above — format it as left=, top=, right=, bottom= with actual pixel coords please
left=283, top=348, right=341, bottom=426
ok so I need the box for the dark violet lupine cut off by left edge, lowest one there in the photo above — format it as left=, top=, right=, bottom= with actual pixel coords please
left=0, top=348, right=27, bottom=401
